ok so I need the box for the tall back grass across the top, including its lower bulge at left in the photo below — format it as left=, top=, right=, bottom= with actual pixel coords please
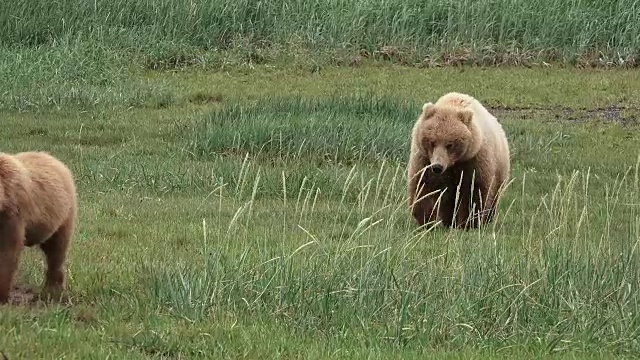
left=0, top=0, right=640, bottom=110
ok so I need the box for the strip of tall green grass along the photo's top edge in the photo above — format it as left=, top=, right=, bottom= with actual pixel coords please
left=0, top=0, right=640, bottom=66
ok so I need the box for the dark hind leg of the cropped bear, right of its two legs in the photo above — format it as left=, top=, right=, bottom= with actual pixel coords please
left=40, top=216, right=74, bottom=299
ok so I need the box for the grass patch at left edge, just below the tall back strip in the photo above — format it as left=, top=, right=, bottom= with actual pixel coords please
left=0, top=41, right=180, bottom=111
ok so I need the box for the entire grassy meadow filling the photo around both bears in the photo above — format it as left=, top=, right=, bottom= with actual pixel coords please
left=0, top=0, right=640, bottom=360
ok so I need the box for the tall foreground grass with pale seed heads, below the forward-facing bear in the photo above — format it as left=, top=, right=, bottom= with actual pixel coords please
left=144, top=154, right=640, bottom=353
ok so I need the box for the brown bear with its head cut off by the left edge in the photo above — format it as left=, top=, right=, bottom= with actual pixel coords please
left=0, top=151, right=77, bottom=304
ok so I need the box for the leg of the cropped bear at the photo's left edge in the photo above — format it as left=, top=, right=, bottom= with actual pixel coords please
left=0, top=218, right=24, bottom=304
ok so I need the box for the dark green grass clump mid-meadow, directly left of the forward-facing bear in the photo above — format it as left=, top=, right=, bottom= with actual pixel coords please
left=186, top=96, right=420, bottom=165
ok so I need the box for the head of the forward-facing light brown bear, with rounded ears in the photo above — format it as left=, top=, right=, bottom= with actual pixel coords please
left=415, top=102, right=482, bottom=174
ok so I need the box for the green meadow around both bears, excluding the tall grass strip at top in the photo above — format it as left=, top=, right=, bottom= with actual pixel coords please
left=0, top=65, right=640, bottom=359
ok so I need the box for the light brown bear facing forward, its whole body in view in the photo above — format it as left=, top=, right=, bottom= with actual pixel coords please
left=408, top=92, right=510, bottom=229
